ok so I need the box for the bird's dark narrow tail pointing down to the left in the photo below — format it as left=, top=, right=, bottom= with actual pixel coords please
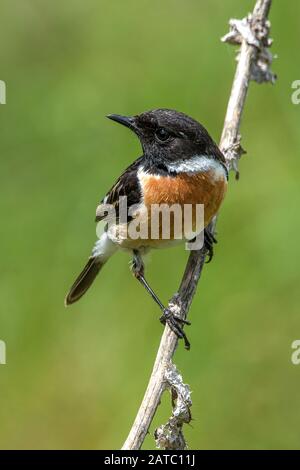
left=65, top=257, right=104, bottom=305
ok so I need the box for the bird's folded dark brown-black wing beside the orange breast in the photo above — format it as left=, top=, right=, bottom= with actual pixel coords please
left=96, top=156, right=144, bottom=222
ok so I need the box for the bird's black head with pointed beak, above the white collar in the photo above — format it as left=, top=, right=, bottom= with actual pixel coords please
left=107, top=109, right=224, bottom=162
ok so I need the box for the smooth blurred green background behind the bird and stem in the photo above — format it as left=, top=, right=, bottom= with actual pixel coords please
left=0, top=0, right=300, bottom=449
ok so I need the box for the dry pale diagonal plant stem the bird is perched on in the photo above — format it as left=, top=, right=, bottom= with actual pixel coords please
left=122, top=0, right=276, bottom=450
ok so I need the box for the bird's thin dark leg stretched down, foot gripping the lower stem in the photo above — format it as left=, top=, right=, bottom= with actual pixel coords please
left=132, top=250, right=190, bottom=349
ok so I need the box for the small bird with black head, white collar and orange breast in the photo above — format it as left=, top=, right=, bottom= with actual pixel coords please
left=65, top=108, right=228, bottom=349
